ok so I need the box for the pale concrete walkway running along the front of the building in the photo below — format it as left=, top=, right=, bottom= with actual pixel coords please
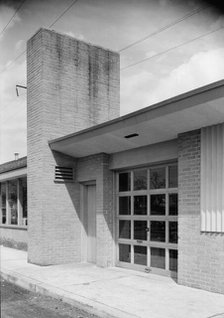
left=1, top=247, right=224, bottom=318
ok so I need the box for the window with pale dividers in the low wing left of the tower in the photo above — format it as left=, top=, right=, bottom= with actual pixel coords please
left=0, top=178, right=27, bottom=226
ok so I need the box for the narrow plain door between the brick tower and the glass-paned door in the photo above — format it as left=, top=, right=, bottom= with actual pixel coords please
left=85, top=184, right=96, bottom=263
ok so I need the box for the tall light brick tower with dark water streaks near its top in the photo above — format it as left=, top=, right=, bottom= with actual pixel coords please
left=27, top=29, right=119, bottom=265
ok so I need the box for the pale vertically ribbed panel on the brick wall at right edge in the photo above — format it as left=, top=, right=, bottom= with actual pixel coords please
left=201, top=124, right=224, bottom=233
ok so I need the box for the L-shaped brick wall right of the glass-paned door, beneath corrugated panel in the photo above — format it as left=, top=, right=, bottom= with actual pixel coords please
left=178, top=130, right=224, bottom=293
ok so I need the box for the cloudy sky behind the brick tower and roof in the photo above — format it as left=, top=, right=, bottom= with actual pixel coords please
left=0, top=0, right=224, bottom=163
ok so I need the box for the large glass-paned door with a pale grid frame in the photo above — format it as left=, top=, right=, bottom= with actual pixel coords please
left=117, top=164, right=178, bottom=275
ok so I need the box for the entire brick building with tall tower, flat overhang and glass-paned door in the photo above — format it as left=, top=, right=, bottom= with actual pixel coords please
left=0, top=29, right=224, bottom=293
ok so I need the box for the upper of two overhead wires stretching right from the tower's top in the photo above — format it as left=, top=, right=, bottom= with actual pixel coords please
left=118, top=6, right=208, bottom=53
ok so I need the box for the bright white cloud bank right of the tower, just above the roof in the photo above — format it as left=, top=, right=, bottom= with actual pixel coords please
left=121, top=48, right=224, bottom=114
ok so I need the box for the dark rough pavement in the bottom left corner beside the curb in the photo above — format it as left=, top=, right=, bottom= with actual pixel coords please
left=1, top=279, right=99, bottom=318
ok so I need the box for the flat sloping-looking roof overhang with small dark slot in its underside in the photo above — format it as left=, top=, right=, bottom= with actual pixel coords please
left=49, top=80, right=224, bottom=158
